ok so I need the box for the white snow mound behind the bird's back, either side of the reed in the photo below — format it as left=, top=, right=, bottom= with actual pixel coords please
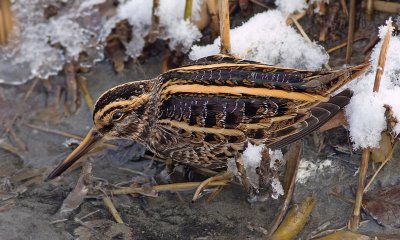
left=189, top=10, right=328, bottom=69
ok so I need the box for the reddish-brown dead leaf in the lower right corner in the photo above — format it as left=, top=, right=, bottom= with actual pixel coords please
left=362, top=185, right=400, bottom=227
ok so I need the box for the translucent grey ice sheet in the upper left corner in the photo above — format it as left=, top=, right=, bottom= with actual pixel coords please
left=0, top=0, right=104, bottom=84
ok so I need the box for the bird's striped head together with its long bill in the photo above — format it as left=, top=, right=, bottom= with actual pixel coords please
left=47, top=80, right=154, bottom=180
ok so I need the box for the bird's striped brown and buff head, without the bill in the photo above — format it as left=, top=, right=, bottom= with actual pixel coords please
left=93, top=80, right=154, bottom=142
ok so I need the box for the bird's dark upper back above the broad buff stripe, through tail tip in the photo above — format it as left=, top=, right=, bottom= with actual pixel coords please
left=173, top=54, right=370, bottom=97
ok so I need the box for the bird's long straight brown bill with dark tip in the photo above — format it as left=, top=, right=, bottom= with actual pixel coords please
left=46, top=128, right=102, bottom=181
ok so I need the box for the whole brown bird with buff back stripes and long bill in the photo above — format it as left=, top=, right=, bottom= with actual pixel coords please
left=47, top=54, right=370, bottom=180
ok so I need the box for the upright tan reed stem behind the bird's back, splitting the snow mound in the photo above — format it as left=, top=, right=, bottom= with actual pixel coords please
left=218, top=0, right=231, bottom=54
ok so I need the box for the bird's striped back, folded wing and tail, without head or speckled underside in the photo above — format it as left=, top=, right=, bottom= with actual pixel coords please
left=157, top=56, right=365, bottom=148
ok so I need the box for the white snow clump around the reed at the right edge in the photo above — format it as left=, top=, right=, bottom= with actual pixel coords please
left=346, top=18, right=400, bottom=149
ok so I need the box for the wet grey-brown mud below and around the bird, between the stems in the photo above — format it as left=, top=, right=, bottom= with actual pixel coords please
left=0, top=4, right=400, bottom=240
